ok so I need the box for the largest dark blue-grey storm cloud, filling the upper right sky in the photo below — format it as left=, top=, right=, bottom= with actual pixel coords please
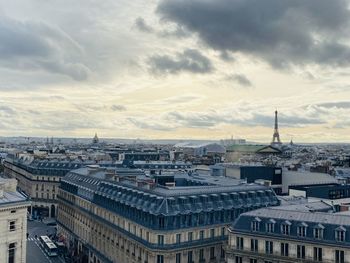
left=157, top=0, right=350, bottom=68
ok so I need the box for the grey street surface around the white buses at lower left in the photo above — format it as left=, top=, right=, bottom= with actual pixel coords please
left=27, top=221, right=64, bottom=263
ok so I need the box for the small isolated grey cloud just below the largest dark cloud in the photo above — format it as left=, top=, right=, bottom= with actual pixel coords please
left=149, top=49, right=213, bottom=74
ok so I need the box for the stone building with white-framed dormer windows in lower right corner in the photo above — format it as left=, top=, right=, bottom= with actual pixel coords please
left=226, top=207, right=350, bottom=263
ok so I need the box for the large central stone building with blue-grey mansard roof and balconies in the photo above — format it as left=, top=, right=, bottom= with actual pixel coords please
left=57, top=167, right=278, bottom=263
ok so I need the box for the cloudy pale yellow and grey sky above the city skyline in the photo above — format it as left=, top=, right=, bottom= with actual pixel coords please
left=0, top=0, right=350, bottom=143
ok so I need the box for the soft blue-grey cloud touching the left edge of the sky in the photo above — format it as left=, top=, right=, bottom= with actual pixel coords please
left=0, top=16, right=89, bottom=81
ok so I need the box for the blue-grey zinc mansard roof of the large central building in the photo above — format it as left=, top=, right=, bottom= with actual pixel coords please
left=61, top=168, right=279, bottom=216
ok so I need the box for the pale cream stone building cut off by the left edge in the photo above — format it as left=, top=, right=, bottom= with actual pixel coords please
left=0, top=178, right=30, bottom=263
